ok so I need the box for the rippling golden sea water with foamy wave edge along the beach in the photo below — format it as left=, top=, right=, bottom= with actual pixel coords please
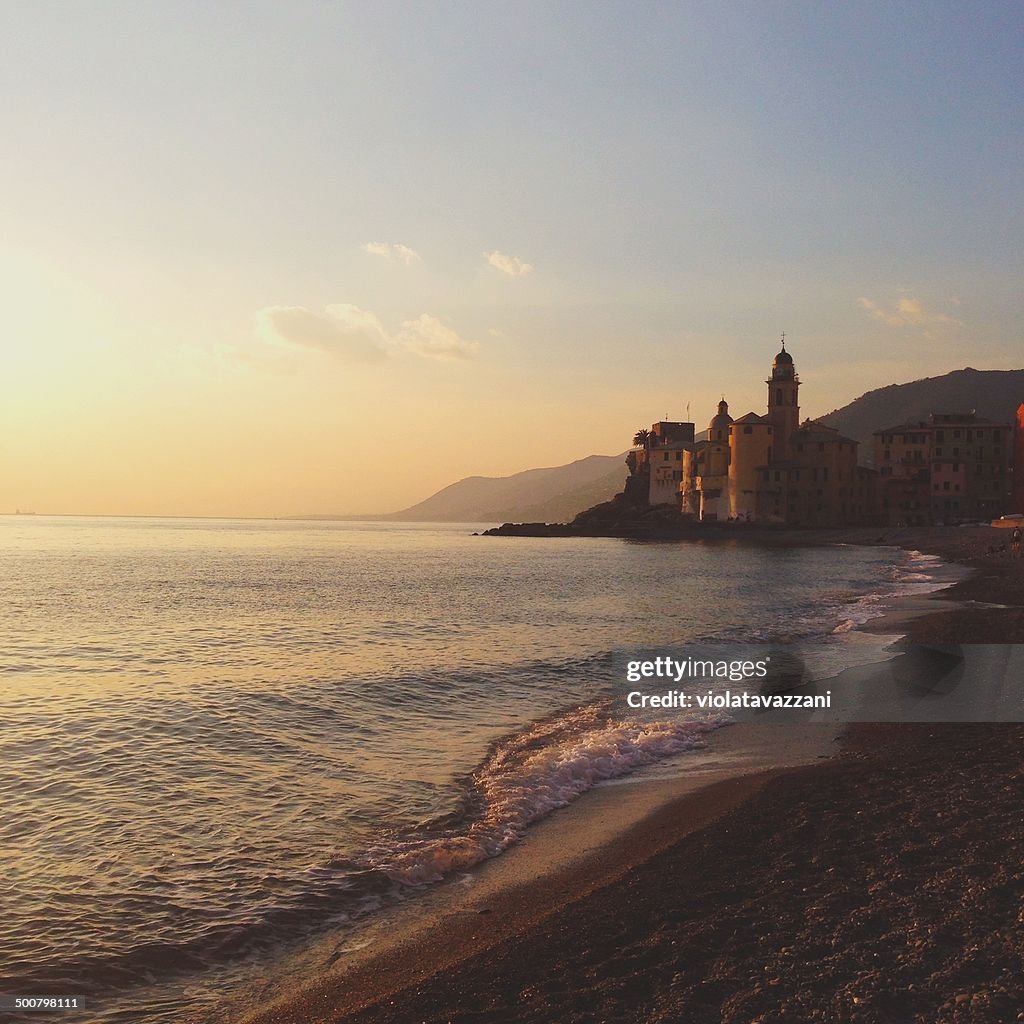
left=0, top=517, right=931, bottom=1022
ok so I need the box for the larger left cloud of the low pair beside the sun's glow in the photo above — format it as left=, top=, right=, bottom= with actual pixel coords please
left=256, top=303, right=390, bottom=362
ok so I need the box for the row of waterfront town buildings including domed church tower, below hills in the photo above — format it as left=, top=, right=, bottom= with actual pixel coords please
left=622, top=337, right=1024, bottom=527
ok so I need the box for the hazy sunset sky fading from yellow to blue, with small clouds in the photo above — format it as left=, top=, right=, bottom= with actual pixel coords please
left=0, top=0, right=1024, bottom=516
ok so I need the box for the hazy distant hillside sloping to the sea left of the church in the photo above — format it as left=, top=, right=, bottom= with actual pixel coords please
left=383, top=452, right=629, bottom=522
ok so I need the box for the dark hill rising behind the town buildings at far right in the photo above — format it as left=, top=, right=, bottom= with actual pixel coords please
left=816, top=367, right=1024, bottom=456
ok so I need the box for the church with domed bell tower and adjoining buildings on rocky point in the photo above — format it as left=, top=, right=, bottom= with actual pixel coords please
left=627, top=338, right=878, bottom=526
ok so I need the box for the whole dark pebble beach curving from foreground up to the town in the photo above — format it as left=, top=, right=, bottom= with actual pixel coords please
left=237, top=529, right=1024, bottom=1024
